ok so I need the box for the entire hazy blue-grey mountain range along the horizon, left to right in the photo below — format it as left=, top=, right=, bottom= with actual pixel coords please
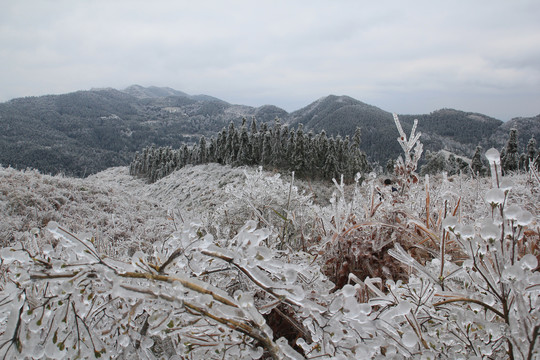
left=0, top=85, right=540, bottom=176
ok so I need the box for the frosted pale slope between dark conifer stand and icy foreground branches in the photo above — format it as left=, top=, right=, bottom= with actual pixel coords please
left=0, top=164, right=324, bottom=255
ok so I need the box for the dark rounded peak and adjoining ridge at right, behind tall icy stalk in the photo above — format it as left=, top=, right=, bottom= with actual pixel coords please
left=290, top=95, right=521, bottom=165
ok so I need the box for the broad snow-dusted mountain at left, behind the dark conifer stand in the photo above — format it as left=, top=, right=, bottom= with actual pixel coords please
left=0, top=85, right=287, bottom=176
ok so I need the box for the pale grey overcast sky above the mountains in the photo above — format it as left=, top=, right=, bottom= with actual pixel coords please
left=0, top=0, right=540, bottom=121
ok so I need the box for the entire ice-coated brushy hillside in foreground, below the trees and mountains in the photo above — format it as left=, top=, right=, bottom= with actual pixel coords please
left=0, top=150, right=540, bottom=359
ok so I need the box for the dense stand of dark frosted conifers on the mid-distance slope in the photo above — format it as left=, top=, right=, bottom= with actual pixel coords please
left=130, top=118, right=371, bottom=182
